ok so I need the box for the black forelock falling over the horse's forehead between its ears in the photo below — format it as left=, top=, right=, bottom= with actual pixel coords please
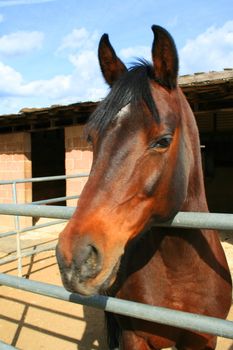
left=87, top=60, right=159, bottom=133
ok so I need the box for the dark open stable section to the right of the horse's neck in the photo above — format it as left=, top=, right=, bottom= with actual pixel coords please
left=179, top=69, right=233, bottom=213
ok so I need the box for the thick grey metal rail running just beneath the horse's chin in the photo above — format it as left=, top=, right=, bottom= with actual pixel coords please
left=0, top=274, right=233, bottom=338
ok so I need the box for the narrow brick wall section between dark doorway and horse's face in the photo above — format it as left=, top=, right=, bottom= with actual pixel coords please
left=65, top=125, right=92, bottom=206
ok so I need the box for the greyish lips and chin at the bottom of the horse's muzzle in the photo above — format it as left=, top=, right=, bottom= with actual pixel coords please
left=58, top=254, right=121, bottom=296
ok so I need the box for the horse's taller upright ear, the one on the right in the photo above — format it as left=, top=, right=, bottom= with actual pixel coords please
left=152, top=25, right=179, bottom=89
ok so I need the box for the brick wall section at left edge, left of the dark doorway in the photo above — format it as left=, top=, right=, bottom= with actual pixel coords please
left=0, top=132, right=32, bottom=230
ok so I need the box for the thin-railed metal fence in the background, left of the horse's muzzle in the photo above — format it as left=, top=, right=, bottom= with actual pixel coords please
left=0, top=173, right=89, bottom=276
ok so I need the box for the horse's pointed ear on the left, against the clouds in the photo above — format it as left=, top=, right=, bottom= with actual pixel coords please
left=98, top=34, right=127, bottom=86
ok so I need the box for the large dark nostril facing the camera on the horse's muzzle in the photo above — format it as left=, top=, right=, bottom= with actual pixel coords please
left=75, top=244, right=101, bottom=280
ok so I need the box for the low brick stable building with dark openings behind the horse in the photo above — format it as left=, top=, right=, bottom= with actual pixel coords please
left=0, top=69, right=233, bottom=227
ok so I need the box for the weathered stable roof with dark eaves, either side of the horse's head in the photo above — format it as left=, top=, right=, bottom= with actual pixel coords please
left=0, top=68, right=233, bottom=133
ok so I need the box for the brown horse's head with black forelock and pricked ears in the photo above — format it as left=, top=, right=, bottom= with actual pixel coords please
left=57, top=26, right=206, bottom=295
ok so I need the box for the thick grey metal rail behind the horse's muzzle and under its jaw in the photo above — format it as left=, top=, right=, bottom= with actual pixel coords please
left=0, top=204, right=233, bottom=230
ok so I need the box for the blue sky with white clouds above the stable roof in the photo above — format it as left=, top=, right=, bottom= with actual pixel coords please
left=0, top=0, right=233, bottom=115
